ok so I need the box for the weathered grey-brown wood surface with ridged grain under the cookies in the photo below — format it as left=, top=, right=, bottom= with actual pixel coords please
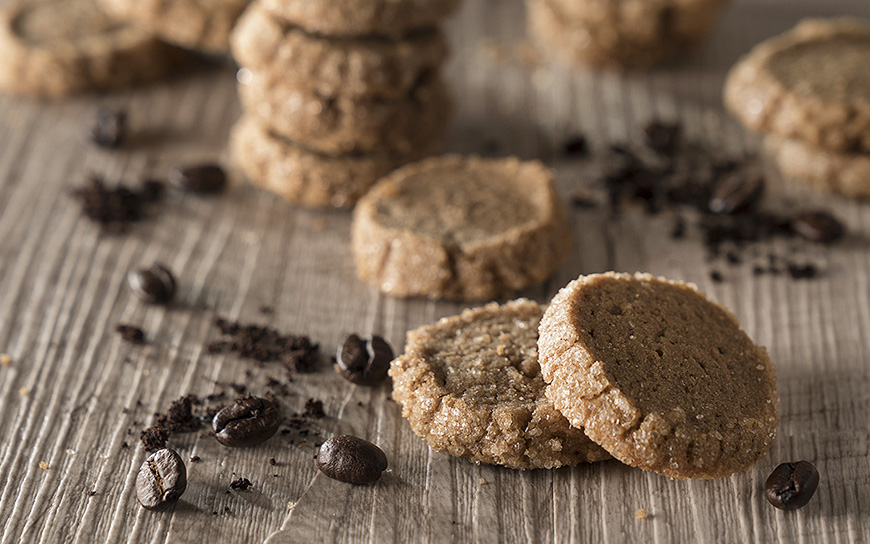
left=0, top=0, right=870, bottom=544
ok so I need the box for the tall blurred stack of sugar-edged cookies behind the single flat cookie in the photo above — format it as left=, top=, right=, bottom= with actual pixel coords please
left=230, top=0, right=459, bottom=207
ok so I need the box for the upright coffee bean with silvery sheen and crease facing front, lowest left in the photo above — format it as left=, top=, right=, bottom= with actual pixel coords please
left=136, top=449, right=187, bottom=510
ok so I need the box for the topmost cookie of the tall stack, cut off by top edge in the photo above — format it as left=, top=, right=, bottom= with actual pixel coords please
left=261, top=0, right=460, bottom=37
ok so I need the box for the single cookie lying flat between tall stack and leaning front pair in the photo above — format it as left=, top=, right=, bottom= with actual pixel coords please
left=351, top=156, right=571, bottom=300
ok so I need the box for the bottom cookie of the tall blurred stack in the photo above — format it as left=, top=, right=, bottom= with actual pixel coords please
left=230, top=116, right=437, bottom=208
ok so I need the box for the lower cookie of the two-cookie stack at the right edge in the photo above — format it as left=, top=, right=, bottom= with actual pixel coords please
left=764, top=136, right=870, bottom=198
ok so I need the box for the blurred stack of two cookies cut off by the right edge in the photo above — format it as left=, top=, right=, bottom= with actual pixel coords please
left=725, top=18, right=870, bottom=198
